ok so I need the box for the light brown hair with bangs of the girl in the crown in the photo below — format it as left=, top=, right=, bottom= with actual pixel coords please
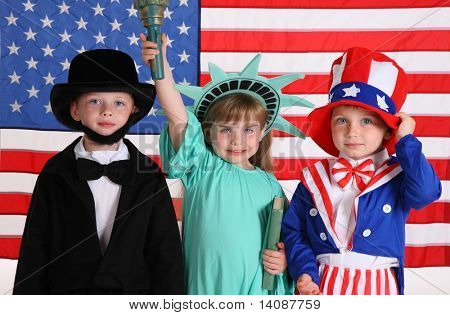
left=202, top=93, right=273, bottom=172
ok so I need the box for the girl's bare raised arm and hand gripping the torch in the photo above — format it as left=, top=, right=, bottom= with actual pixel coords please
left=139, top=34, right=188, bottom=151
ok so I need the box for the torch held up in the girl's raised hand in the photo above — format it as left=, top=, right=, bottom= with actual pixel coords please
left=133, top=0, right=169, bottom=80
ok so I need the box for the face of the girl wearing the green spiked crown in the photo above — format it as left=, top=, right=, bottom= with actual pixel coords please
left=208, top=120, right=264, bottom=169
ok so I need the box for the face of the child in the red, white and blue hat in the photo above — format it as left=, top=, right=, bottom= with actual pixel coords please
left=331, top=105, right=391, bottom=160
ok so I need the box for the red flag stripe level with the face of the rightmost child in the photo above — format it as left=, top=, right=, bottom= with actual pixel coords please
left=272, top=115, right=450, bottom=137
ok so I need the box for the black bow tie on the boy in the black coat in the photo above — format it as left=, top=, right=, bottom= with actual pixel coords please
left=77, top=158, right=133, bottom=185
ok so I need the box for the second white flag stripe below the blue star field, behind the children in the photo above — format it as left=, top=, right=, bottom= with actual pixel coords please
left=0, top=173, right=450, bottom=202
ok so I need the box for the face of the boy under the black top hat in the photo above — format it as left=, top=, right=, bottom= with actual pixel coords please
left=70, top=92, right=138, bottom=136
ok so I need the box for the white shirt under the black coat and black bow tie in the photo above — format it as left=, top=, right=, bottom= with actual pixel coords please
left=74, top=138, right=130, bottom=254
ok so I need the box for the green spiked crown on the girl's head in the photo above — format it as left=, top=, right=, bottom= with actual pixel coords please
left=175, top=54, right=314, bottom=138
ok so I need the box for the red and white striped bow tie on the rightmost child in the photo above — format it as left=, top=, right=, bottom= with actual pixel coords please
left=331, top=158, right=375, bottom=191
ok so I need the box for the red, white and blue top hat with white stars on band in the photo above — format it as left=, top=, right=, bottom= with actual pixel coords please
left=308, top=47, right=407, bottom=156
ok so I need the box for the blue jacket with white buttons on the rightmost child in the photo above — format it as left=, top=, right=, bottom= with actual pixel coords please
left=282, top=135, right=442, bottom=294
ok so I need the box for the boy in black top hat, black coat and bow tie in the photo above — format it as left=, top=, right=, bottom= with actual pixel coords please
left=14, top=49, right=184, bottom=294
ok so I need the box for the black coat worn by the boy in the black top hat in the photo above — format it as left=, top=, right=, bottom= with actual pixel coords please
left=14, top=138, right=185, bottom=294
